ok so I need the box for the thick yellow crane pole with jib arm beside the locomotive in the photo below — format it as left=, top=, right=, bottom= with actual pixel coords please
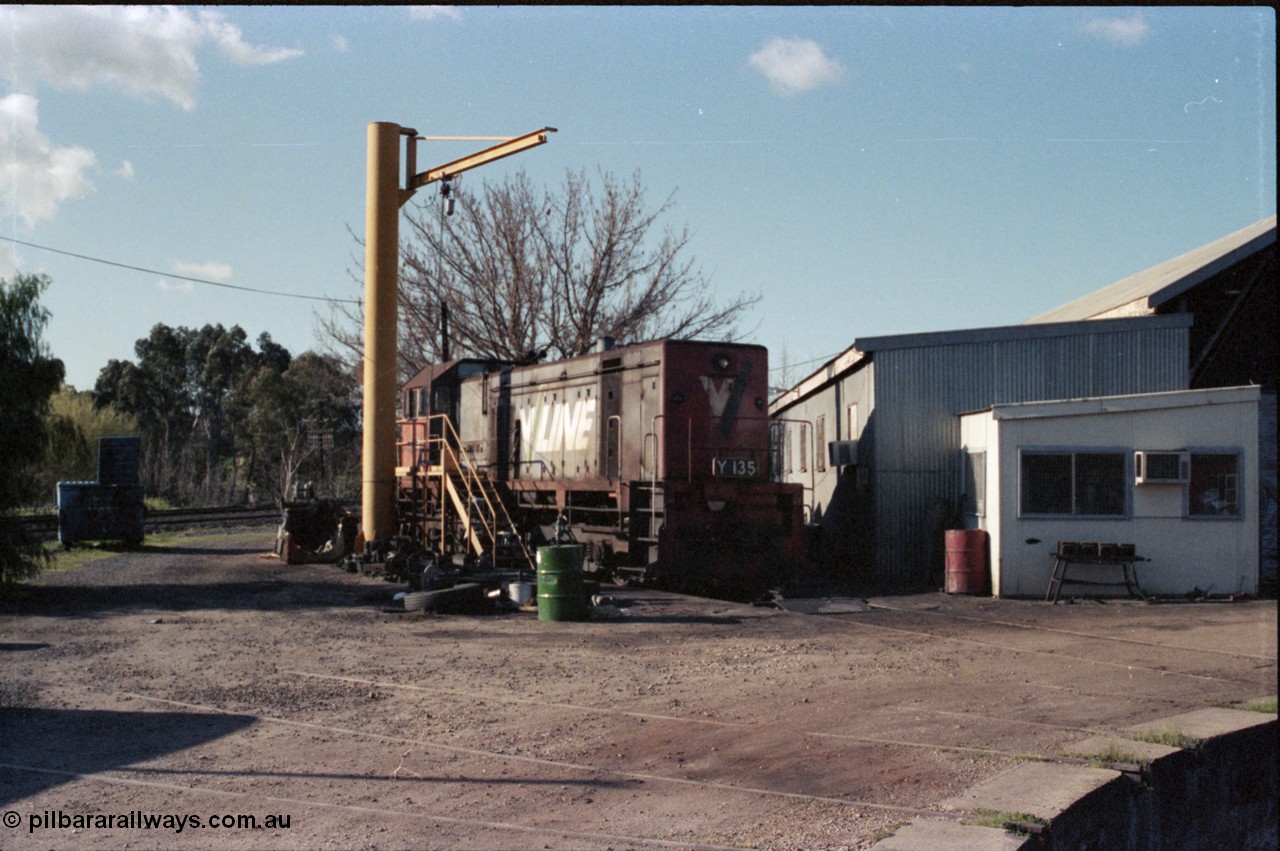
left=361, top=122, right=556, bottom=541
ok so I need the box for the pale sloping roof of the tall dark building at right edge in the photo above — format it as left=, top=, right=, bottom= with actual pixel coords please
left=1027, top=215, right=1276, bottom=324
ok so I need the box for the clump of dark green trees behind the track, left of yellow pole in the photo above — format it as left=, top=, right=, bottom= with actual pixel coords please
left=93, top=324, right=358, bottom=504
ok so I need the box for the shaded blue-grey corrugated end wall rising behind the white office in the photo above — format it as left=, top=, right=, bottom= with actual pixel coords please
left=864, top=322, right=1188, bottom=585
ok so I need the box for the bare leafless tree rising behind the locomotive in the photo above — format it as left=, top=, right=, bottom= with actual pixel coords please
left=320, top=171, right=759, bottom=375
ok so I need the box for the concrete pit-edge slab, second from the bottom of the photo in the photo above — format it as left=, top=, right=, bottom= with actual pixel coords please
left=941, top=763, right=1119, bottom=822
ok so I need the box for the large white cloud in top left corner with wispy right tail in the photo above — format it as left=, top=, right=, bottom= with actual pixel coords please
left=0, top=5, right=302, bottom=109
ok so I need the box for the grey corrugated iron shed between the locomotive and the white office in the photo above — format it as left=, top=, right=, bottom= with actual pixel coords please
left=771, top=315, right=1192, bottom=586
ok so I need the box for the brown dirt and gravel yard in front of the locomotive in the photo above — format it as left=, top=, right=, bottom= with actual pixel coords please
left=0, top=530, right=1276, bottom=848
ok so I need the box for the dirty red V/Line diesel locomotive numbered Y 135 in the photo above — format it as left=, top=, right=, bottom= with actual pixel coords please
left=397, top=340, right=803, bottom=596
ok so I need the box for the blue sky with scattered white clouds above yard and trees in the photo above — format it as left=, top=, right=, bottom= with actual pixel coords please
left=0, top=6, right=1276, bottom=389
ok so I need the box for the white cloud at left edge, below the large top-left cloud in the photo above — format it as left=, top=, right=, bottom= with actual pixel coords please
left=0, top=95, right=97, bottom=228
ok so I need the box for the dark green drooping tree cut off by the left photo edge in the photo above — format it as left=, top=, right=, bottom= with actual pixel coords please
left=0, top=274, right=65, bottom=584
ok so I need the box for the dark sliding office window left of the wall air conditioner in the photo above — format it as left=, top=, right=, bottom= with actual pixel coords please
left=1020, top=452, right=1126, bottom=517
